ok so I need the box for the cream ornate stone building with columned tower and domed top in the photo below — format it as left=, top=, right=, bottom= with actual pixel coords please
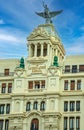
left=0, top=11, right=84, bottom=130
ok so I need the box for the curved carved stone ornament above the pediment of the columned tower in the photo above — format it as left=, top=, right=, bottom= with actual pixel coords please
left=27, top=27, right=49, bottom=40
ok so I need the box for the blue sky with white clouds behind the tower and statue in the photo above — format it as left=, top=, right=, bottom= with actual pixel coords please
left=0, top=0, right=84, bottom=59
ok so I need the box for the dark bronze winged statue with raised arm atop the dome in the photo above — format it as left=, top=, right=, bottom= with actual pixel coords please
left=36, top=2, right=63, bottom=24
